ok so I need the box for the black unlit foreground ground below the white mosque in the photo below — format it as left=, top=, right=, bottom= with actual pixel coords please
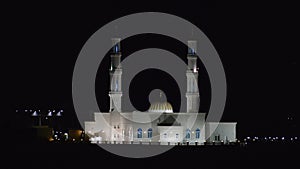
left=9, top=143, right=300, bottom=169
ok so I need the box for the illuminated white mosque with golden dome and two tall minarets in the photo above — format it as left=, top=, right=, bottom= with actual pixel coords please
left=84, top=38, right=237, bottom=145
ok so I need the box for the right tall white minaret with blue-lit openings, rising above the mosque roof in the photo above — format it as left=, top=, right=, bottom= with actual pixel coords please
left=186, top=41, right=200, bottom=113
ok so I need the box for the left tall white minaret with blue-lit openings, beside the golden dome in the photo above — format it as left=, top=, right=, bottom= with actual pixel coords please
left=109, top=38, right=122, bottom=112
